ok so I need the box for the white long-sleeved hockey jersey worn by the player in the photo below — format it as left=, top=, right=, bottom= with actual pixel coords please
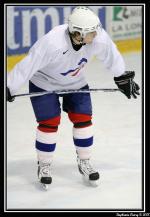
left=7, top=24, right=125, bottom=95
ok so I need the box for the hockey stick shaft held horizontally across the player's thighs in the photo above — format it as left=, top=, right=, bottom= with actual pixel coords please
left=13, top=88, right=120, bottom=97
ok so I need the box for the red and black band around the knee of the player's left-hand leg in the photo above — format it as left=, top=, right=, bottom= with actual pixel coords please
left=38, top=116, right=60, bottom=133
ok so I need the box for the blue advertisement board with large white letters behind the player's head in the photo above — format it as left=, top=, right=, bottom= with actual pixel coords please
left=6, top=6, right=105, bottom=56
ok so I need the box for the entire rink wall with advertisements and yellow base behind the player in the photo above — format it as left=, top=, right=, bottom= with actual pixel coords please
left=6, top=5, right=142, bottom=71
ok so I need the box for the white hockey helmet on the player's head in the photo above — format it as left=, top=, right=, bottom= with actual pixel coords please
left=68, top=6, right=101, bottom=38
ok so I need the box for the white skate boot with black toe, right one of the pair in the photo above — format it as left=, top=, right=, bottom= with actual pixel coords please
left=77, top=157, right=100, bottom=186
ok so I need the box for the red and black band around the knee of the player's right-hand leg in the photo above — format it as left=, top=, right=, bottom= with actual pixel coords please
left=68, top=112, right=92, bottom=128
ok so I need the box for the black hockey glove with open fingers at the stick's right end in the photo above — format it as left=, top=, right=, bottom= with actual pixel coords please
left=114, top=71, right=140, bottom=99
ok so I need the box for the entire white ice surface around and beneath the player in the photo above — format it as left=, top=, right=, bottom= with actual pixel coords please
left=5, top=53, right=142, bottom=210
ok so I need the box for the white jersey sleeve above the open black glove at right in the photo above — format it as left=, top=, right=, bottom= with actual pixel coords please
left=96, top=30, right=125, bottom=77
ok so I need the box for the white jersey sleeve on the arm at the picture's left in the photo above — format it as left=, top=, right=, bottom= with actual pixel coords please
left=7, top=37, right=57, bottom=95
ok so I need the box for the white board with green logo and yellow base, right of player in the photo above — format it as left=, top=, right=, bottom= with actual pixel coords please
left=105, top=6, right=142, bottom=53
